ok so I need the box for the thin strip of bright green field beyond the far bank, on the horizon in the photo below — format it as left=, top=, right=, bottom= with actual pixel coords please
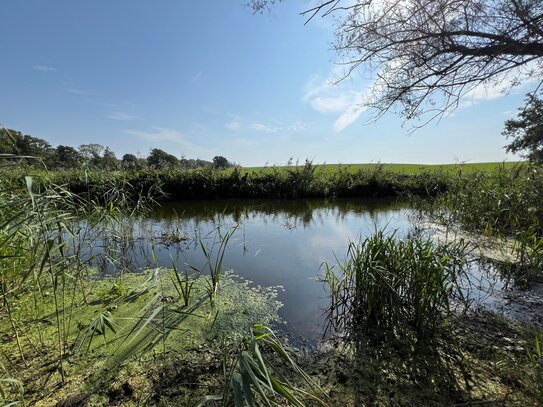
left=243, top=161, right=524, bottom=174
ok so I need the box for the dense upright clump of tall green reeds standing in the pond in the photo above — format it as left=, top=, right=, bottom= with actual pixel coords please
left=323, top=230, right=463, bottom=339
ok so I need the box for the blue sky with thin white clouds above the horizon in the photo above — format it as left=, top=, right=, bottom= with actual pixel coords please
left=0, top=0, right=532, bottom=166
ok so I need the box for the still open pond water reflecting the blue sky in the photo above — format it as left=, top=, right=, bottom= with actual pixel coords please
left=96, top=199, right=411, bottom=341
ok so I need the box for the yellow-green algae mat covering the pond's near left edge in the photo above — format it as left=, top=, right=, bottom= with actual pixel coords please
left=0, top=269, right=281, bottom=406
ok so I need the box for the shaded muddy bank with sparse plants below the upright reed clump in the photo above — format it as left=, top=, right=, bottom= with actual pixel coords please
left=304, top=310, right=543, bottom=406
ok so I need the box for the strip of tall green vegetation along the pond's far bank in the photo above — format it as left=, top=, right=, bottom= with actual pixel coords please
left=3, top=163, right=474, bottom=200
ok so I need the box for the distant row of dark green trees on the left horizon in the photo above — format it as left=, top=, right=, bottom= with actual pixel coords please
left=0, top=128, right=234, bottom=171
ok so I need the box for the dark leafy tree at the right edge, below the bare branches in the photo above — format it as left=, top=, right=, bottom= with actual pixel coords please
left=502, top=94, right=543, bottom=163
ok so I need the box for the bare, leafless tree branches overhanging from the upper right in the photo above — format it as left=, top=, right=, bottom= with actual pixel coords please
left=249, top=0, right=543, bottom=124
